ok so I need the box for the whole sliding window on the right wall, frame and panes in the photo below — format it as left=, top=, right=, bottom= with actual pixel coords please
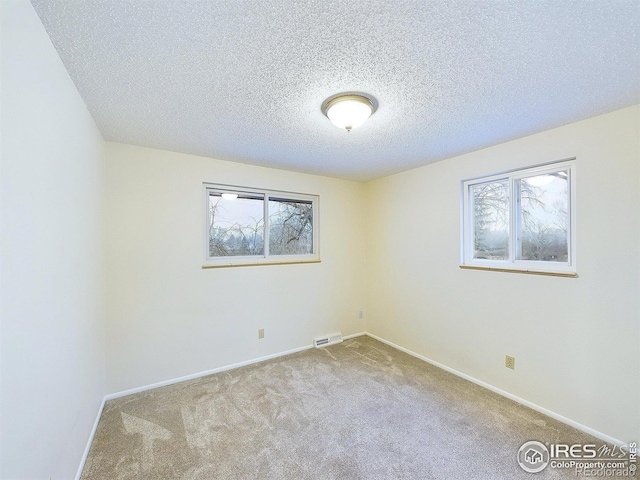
left=461, top=161, right=576, bottom=276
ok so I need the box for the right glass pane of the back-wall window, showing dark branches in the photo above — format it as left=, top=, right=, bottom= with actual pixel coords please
left=269, top=198, right=313, bottom=255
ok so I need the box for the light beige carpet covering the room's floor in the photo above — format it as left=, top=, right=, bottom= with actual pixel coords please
left=82, top=337, right=628, bottom=480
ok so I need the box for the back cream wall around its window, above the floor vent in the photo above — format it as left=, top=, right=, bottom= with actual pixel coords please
left=106, top=143, right=365, bottom=392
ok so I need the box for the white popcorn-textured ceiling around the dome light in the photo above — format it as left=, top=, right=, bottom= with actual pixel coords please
left=32, top=0, right=640, bottom=181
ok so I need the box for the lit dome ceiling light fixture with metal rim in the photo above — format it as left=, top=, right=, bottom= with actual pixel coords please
left=321, top=92, right=378, bottom=132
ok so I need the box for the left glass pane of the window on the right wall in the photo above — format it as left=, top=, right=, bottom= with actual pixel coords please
left=470, top=179, right=509, bottom=260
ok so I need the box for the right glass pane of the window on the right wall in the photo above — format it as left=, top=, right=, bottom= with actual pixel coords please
left=516, top=170, right=569, bottom=262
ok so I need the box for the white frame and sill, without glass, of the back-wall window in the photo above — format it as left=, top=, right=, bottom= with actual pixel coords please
left=202, top=182, right=320, bottom=269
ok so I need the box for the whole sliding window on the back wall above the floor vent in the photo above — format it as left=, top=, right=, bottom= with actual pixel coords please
left=205, top=184, right=320, bottom=267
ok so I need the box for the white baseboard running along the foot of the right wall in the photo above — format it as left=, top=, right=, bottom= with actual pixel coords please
left=367, top=332, right=626, bottom=446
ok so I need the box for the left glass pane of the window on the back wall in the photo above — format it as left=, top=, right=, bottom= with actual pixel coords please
left=209, top=192, right=264, bottom=257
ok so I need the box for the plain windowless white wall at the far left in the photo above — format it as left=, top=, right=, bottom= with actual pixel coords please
left=0, top=0, right=105, bottom=480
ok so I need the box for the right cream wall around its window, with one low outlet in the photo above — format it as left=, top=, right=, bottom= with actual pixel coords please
left=367, top=106, right=640, bottom=441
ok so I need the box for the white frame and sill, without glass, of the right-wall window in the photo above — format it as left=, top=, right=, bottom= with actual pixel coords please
left=460, top=158, right=578, bottom=277
